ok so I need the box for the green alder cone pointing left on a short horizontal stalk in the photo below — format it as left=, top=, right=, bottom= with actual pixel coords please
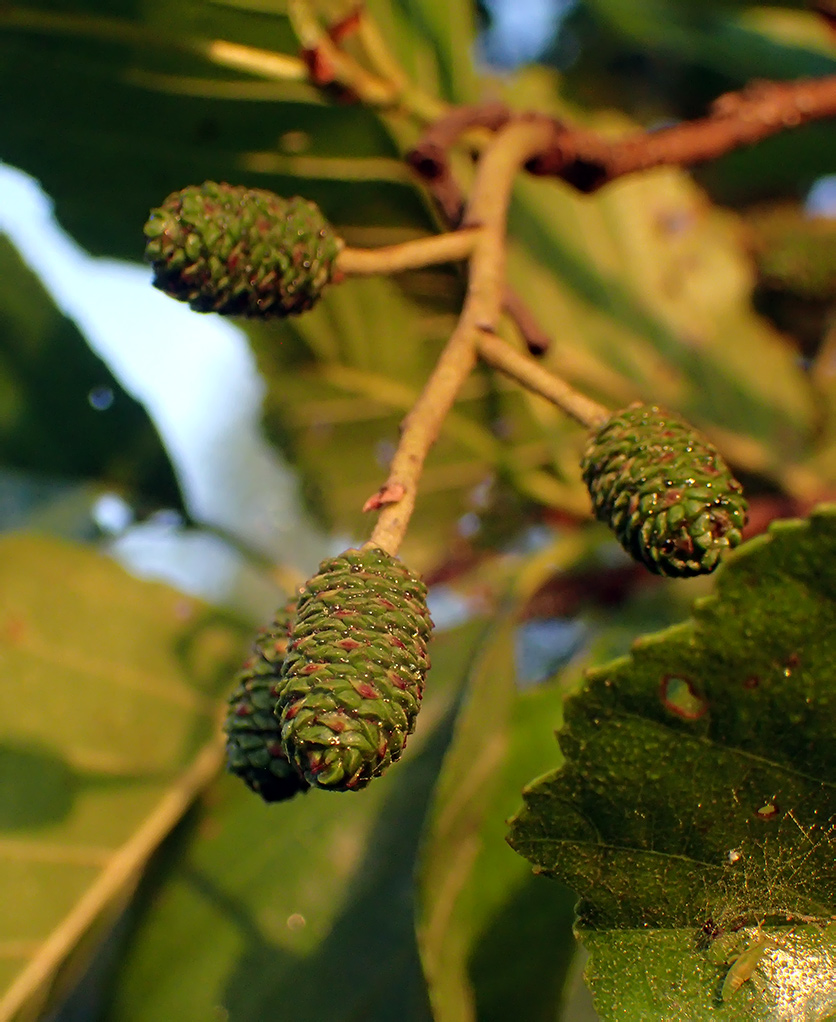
left=144, top=181, right=342, bottom=318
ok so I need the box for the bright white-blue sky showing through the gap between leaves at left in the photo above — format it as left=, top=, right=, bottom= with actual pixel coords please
left=0, top=164, right=324, bottom=613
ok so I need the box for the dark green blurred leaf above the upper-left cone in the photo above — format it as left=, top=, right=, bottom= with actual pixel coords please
left=0, top=0, right=430, bottom=259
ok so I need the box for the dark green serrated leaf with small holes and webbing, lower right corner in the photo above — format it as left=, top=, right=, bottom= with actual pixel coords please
left=504, top=506, right=836, bottom=1022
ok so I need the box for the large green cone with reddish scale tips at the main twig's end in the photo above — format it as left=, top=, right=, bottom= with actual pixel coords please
left=276, top=548, right=432, bottom=791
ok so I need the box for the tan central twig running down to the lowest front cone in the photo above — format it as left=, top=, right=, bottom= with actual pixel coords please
left=369, top=120, right=549, bottom=554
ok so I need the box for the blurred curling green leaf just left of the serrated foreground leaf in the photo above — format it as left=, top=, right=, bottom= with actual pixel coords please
left=418, top=536, right=703, bottom=1022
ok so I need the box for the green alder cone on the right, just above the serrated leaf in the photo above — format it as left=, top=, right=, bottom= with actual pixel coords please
left=580, top=404, right=746, bottom=576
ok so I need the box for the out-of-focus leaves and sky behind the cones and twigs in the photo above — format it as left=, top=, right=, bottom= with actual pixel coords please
left=0, top=0, right=836, bottom=1022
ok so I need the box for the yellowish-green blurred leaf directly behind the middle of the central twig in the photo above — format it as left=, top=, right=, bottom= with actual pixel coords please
left=244, top=279, right=550, bottom=568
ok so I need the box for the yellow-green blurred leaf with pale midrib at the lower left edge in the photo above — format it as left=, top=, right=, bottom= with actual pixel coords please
left=0, top=535, right=247, bottom=1022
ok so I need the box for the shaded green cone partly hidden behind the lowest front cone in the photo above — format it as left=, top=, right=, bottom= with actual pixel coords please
left=224, top=604, right=309, bottom=802
